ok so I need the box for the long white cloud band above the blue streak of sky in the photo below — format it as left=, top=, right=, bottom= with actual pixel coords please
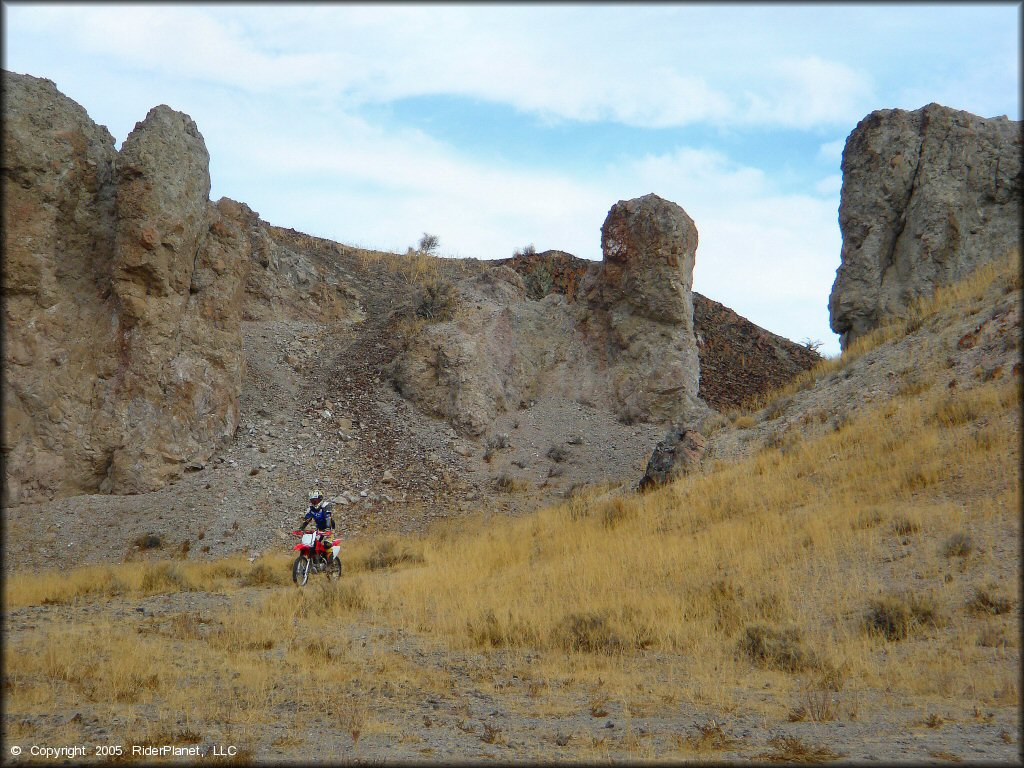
left=0, top=5, right=884, bottom=127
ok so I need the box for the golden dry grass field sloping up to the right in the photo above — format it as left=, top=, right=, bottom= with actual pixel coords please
left=3, top=255, right=1021, bottom=762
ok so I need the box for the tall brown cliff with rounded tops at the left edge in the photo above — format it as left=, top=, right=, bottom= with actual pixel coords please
left=3, top=72, right=258, bottom=504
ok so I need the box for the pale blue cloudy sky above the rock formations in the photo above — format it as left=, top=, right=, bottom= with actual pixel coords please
left=3, top=2, right=1021, bottom=355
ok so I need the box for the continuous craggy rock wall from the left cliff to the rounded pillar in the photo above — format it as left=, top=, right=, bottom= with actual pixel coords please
left=2, top=73, right=823, bottom=505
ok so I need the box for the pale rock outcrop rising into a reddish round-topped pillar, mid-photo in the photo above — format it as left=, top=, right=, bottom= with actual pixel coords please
left=392, top=195, right=707, bottom=435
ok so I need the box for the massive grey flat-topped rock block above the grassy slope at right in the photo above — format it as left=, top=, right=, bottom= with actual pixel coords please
left=828, top=103, right=1022, bottom=348
